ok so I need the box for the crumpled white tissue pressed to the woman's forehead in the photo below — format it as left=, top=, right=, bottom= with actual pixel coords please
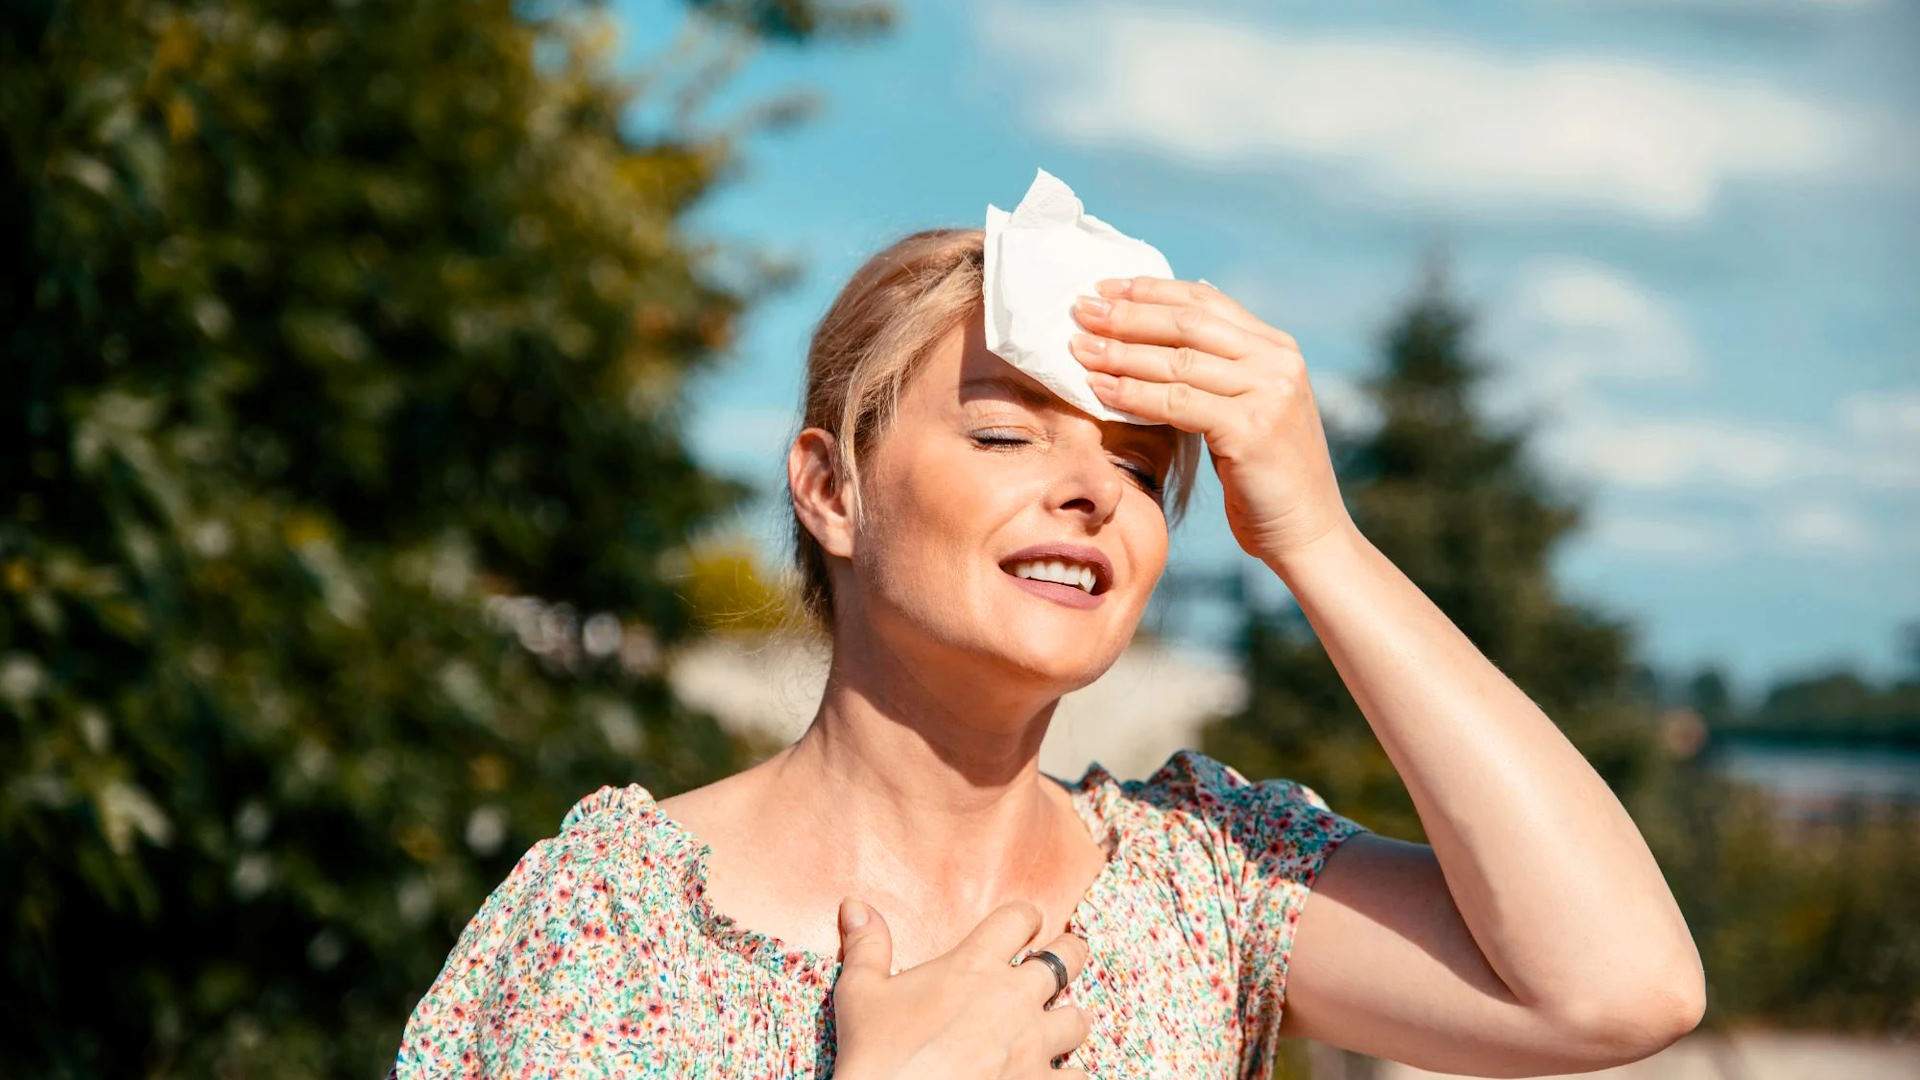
left=985, top=169, right=1173, bottom=425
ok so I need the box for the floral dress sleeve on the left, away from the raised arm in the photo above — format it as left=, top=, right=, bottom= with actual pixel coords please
left=394, top=788, right=660, bottom=1080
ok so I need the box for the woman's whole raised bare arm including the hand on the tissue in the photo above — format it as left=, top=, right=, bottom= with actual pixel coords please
left=1071, top=277, right=1705, bottom=1074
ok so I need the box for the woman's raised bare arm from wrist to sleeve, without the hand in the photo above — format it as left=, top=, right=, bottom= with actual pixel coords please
left=1269, top=528, right=1705, bottom=1076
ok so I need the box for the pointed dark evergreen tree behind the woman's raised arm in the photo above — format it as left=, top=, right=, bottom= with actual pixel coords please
left=1202, top=255, right=1657, bottom=840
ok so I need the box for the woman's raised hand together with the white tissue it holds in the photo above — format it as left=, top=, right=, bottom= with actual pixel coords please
left=981, top=169, right=1357, bottom=564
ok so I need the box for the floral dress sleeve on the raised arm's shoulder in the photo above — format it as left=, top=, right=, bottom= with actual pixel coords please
left=1146, top=749, right=1367, bottom=1034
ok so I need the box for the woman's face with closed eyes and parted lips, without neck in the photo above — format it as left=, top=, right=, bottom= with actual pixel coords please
left=835, top=307, right=1177, bottom=692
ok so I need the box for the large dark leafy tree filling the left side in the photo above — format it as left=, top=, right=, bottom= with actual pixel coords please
left=0, top=0, right=876, bottom=1078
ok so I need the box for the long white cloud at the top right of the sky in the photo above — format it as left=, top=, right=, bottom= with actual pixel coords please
left=981, top=4, right=1912, bottom=221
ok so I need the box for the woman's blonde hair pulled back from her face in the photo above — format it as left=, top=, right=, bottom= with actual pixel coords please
left=789, top=229, right=1202, bottom=634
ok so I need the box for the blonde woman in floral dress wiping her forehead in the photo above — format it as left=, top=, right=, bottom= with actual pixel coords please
left=385, top=229, right=1705, bottom=1080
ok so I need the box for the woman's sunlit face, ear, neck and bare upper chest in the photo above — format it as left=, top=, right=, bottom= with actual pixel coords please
left=660, top=319, right=1175, bottom=969
